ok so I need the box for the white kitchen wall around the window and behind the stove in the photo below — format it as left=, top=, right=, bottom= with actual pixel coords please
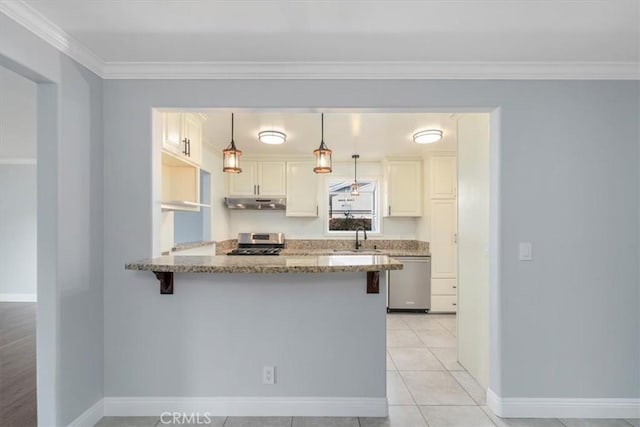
left=224, top=161, right=418, bottom=239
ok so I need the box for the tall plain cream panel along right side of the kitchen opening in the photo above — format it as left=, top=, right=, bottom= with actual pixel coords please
left=458, top=114, right=489, bottom=388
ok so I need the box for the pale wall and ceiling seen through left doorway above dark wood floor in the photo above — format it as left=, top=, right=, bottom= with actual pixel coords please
left=0, top=66, right=37, bottom=301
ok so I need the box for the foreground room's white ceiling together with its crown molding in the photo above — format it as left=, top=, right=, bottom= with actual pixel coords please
left=0, top=0, right=640, bottom=78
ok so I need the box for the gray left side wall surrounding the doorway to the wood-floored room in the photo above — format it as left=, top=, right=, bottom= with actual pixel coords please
left=0, top=14, right=104, bottom=426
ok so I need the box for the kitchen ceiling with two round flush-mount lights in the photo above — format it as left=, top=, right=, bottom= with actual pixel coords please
left=200, top=111, right=458, bottom=161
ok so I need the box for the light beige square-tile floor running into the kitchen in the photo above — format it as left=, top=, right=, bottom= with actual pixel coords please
left=97, top=313, right=640, bottom=427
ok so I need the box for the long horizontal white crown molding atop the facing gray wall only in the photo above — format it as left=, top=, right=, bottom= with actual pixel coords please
left=104, top=62, right=640, bottom=80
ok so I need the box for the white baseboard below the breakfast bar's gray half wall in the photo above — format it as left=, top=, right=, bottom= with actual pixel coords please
left=104, top=397, right=387, bottom=417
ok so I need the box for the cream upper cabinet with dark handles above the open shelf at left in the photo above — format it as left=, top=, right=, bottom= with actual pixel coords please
left=161, top=113, right=202, bottom=166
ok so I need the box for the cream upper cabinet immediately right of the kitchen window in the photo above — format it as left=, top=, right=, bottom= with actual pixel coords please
left=384, top=160, right=422, bottom=217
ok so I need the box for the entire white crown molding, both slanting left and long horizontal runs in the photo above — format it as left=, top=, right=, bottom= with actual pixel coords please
left=0, top=0, right=640, bottom=80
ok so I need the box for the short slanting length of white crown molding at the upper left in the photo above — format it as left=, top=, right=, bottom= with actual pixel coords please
left=0, top=0, right=104, bottom=77
